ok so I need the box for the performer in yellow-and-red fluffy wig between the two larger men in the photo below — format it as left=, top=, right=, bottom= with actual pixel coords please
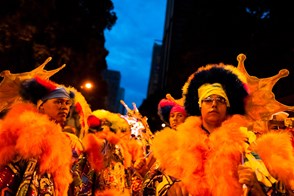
left=83, top=109, right=144, bottom=196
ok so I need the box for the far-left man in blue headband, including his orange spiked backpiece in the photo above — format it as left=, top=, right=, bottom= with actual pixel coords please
left=0, top=58, right=97, bottom=196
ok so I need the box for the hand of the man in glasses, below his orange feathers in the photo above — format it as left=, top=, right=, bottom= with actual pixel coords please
left=238, top=165, right=266, bottom=196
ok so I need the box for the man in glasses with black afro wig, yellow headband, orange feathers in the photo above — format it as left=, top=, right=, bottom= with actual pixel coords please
left=151, top=56, right=294, bottom=196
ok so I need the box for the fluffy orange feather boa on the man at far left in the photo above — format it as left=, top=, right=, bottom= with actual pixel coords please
left=0, top=103, right=72, bottom=196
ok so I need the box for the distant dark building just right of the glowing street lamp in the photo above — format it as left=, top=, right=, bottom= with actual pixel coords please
left=102, top=70, right=124, bottom=113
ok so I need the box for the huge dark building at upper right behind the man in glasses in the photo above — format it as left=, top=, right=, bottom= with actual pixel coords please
left=158, top=0, right=294, bottom=102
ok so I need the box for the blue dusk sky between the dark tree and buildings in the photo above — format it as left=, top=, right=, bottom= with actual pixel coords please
left=105, top=0, right=166, bottom=109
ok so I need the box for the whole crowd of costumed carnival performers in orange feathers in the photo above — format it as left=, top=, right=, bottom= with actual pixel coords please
left=0, top=52, right=294, bottom=196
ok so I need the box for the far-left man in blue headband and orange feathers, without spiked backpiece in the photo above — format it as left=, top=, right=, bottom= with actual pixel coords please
left=0, top=77, right=82, bottom=196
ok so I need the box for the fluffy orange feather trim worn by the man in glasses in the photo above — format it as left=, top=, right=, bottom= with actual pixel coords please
left=151, top=115, right=294, bottom=195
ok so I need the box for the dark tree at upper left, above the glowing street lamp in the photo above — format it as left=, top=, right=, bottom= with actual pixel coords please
left=0, top=0, right=117, bottom=109
